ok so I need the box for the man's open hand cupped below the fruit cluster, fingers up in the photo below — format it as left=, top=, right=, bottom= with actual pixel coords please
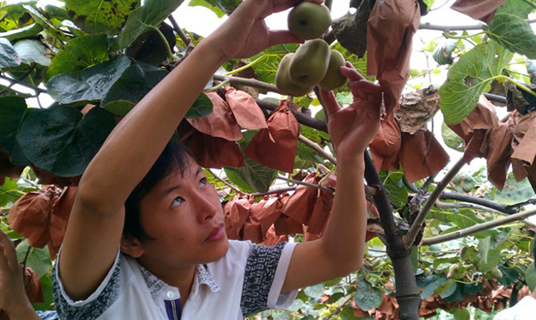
left=320, top=62, right=382, bottom=160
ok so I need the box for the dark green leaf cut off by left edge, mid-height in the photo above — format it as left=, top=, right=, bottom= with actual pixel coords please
left=0, top=97, right=28, bottom=166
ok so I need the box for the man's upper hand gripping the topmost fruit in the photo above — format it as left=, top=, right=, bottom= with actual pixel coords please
left=206, top=0, right=323, bottom=61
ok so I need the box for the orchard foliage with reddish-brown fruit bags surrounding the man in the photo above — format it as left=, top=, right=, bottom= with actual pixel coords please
left=0, top=0, right=536, bottom=319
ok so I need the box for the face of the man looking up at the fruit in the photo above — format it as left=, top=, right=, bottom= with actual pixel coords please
left=134, top=159, right=229, bottom=270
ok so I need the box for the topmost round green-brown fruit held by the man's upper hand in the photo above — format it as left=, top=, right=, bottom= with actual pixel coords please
left=287, top=2, right=331, bottom=40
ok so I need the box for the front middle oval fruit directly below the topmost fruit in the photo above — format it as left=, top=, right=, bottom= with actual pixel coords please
left=289, top=39, right=329, bottom=87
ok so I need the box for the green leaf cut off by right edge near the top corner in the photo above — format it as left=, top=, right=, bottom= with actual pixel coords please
left=484, top=13, right=536, bottom=59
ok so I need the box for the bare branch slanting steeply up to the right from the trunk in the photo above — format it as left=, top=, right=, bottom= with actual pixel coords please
left=403, top=157, right=465, bottom=249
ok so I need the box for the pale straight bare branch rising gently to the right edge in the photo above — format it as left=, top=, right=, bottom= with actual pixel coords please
left=420, top=209, right=536, bottom=246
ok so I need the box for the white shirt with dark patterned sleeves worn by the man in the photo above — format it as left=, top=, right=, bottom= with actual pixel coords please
left=53, top=240, right=297, bottom=320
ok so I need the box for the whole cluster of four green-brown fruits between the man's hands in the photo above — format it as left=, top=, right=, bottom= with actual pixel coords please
left=275, top=2, right=346, bottom=96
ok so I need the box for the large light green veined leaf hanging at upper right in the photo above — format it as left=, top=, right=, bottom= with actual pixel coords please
left=439, top=41, right=513, bottom=125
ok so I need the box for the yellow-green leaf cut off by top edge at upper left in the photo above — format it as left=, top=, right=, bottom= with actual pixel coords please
left=65, top=0, right=141, bottom=35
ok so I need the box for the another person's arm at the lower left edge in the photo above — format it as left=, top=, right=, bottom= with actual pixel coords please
left=0, top=231, right=36, bottom=319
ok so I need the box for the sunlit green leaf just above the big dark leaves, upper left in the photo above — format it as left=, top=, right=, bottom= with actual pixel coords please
left=47, top=34, right=109, bottom=80
